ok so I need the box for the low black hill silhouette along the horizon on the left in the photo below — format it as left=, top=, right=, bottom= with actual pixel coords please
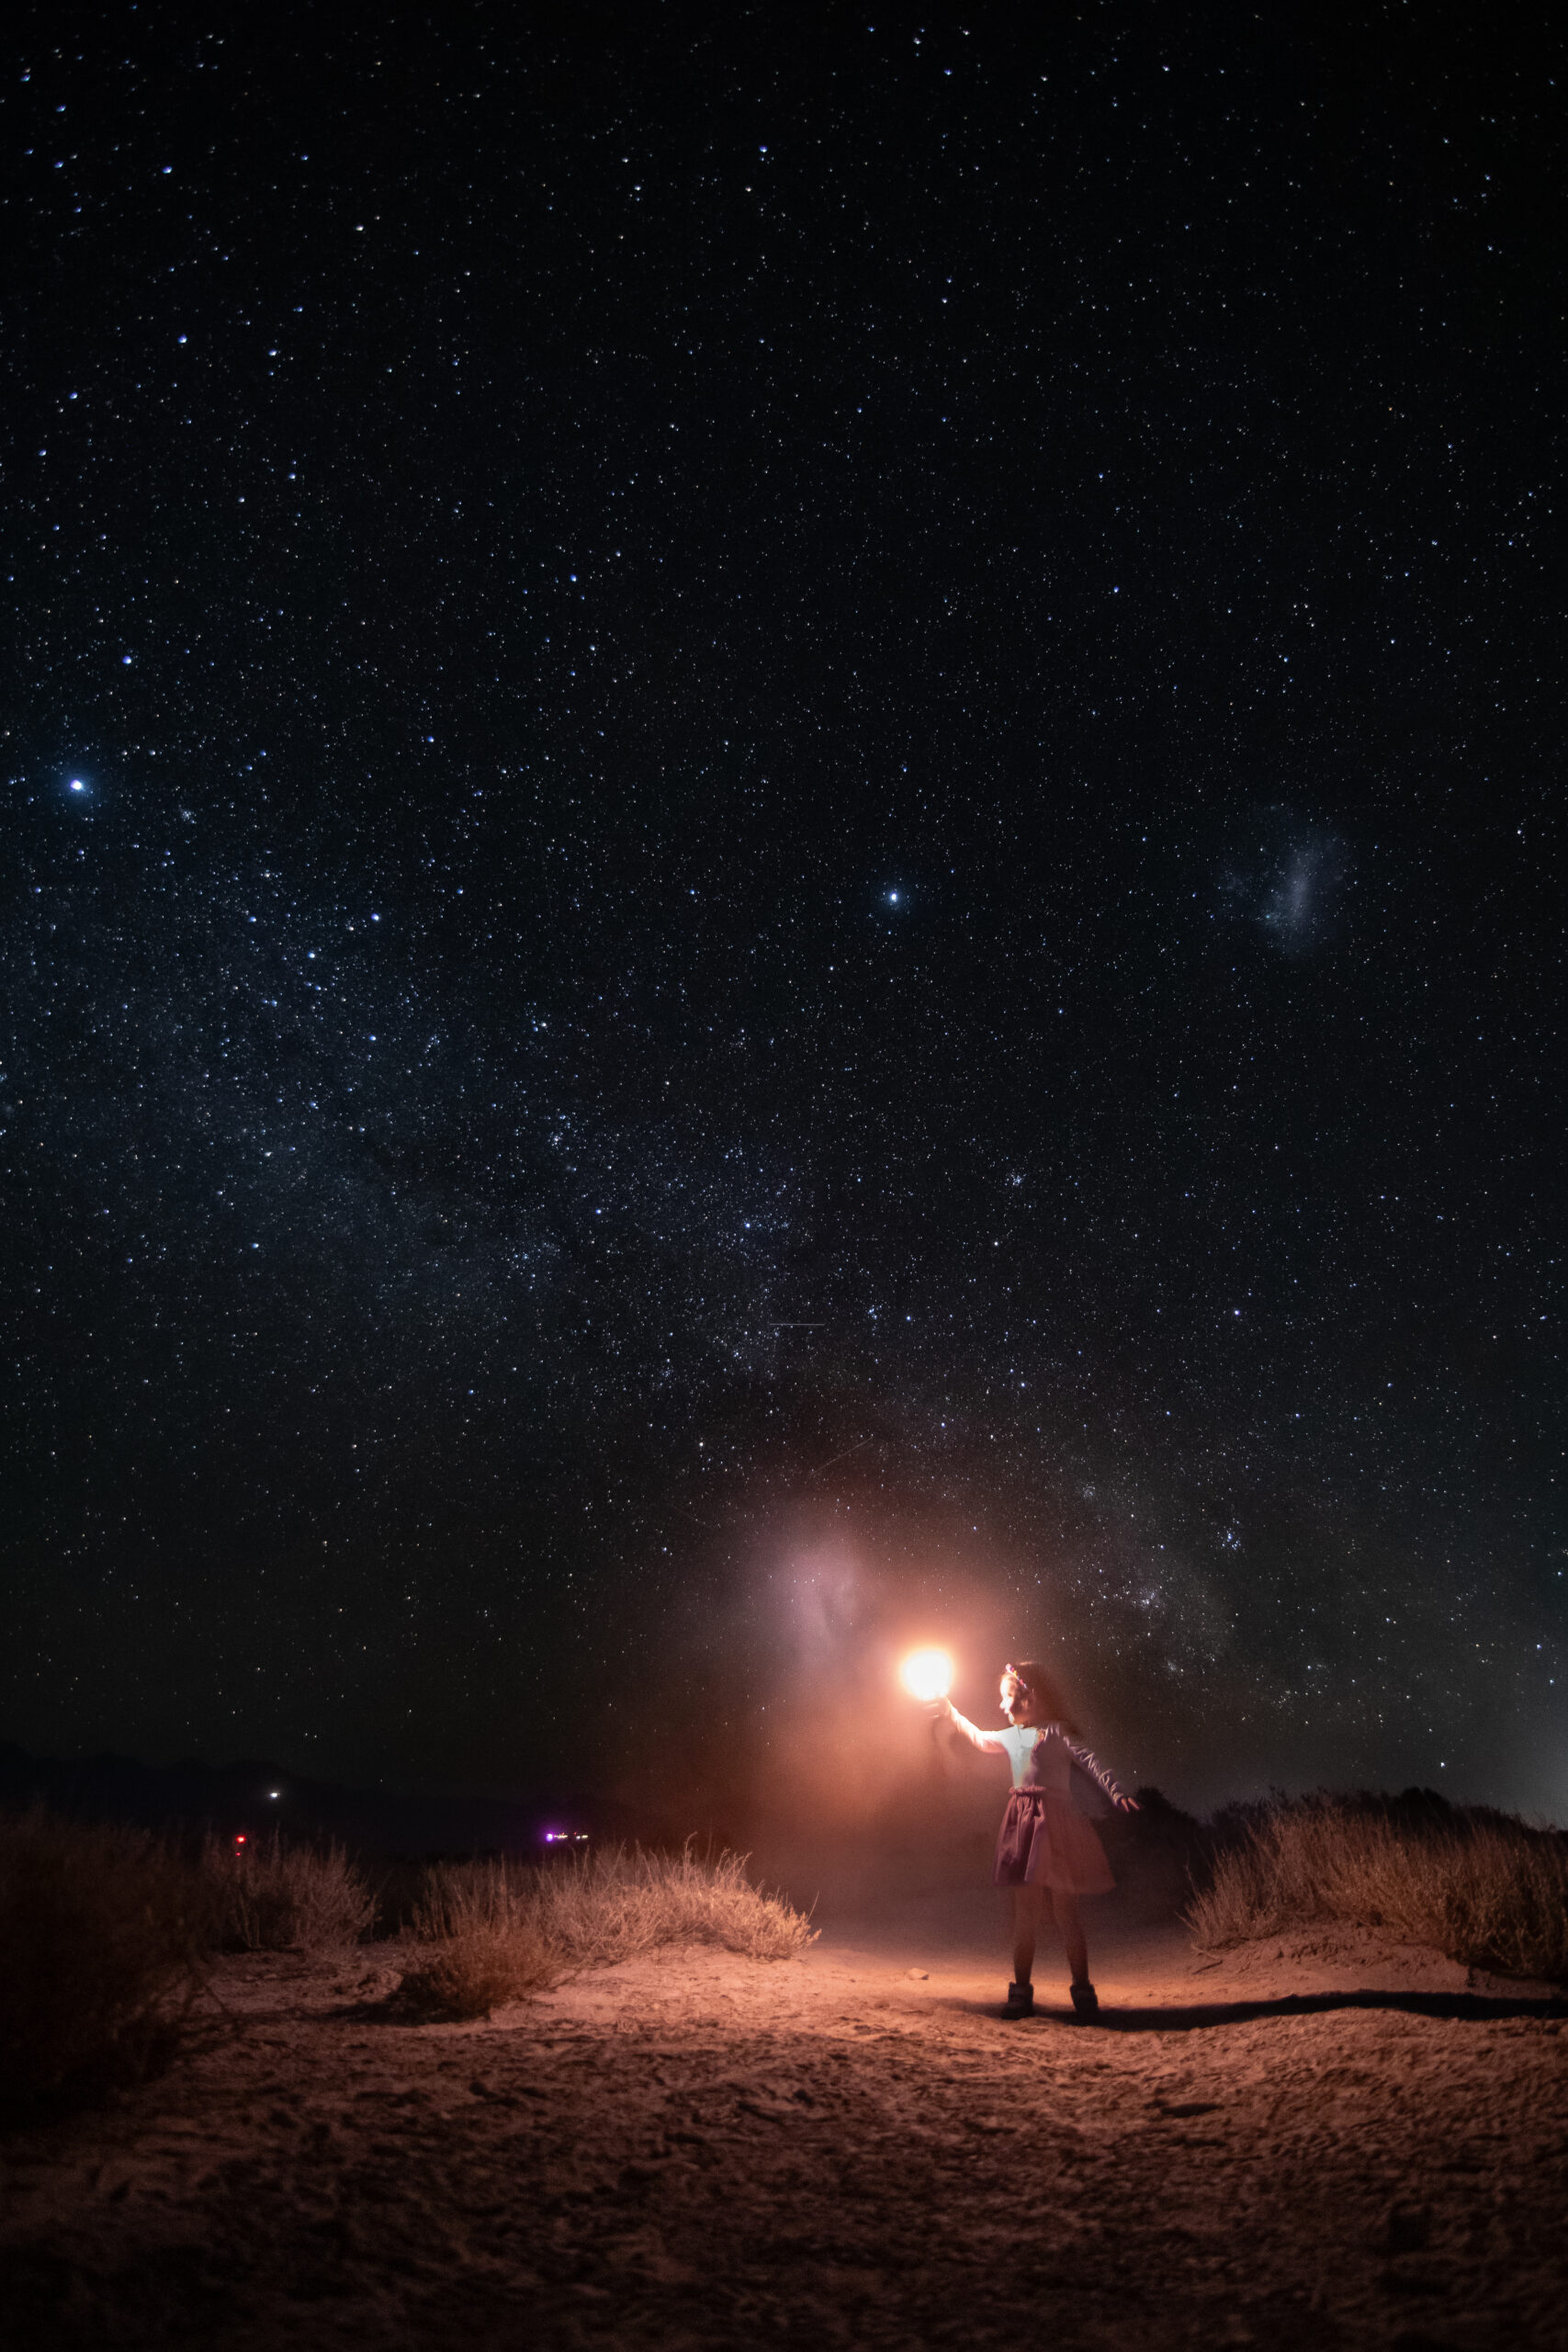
left=0, top=1740, right=672, bottom=1856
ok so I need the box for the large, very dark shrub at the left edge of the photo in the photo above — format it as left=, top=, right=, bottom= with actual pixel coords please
left=0, top=1809, right=214, bottom=2100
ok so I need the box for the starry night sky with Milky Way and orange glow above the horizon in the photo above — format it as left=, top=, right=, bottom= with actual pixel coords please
left=0, top=5, right=1568, bottom=1818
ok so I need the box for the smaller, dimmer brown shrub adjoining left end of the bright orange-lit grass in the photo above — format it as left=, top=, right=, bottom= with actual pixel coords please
left=398, top=1863, right=559, bottom=2018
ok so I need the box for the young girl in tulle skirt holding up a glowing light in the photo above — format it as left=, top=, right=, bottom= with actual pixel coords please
left=938, top=1658, right=1138, bottom=2018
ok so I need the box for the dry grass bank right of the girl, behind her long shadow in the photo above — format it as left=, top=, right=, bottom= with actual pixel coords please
left=1187, top=1797, right=1568, bottom=1981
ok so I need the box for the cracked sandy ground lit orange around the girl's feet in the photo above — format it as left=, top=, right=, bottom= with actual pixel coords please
left=0, top=1895, right=1568, bottom=2352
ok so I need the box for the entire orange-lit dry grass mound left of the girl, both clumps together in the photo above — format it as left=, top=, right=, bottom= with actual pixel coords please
left=400, top=1847, right=816, bottom=2018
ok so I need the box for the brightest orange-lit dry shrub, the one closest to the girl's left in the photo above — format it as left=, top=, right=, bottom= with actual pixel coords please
left=538, top=1847, right=816, bottom=1969
